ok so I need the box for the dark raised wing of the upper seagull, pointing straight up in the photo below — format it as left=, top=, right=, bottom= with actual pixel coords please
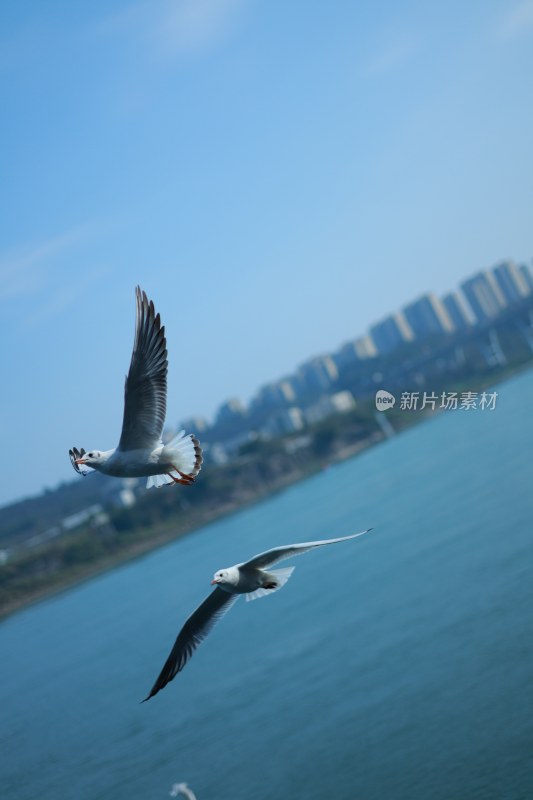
left=118, top=286, right=168, bottom=450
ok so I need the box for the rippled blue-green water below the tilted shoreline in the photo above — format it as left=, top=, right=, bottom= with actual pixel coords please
left=0, top=373, right=533, bottom=800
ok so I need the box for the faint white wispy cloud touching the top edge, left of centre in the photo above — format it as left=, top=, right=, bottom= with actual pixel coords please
left=104, top=0, right=250, bottom=58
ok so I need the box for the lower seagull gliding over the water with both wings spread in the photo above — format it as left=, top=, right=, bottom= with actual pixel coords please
left=142, top=528, right=372, bottom=703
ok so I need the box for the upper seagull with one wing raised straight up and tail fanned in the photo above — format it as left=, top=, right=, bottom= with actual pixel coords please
left=69, top=286, right=203, bottom=488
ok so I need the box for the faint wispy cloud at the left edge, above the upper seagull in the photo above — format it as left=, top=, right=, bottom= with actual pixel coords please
left=0, top=225, right=91, bottom=302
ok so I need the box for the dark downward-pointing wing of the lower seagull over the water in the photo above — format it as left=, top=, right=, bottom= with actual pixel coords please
left=143, top=587, right=239, bottom=703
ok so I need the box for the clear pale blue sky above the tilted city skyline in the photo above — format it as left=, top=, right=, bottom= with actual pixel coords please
left=0, top=0, right=533, bottom=504
